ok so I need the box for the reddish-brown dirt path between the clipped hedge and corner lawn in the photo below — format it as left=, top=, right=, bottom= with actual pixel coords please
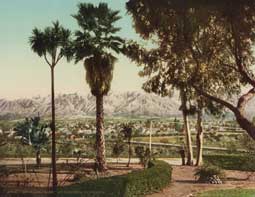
left=147, top=166, right=255, bottom=197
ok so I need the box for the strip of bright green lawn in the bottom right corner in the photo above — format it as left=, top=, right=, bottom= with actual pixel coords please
left=198, top=189, right=255, bottom=197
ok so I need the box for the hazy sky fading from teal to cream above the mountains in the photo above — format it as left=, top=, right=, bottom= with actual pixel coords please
left=0, top=0, right=144, bottom=98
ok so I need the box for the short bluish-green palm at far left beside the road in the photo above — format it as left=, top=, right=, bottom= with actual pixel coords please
left=14, top=117, right=49, bottom=166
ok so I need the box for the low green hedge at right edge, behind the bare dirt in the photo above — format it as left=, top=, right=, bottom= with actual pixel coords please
left=203, top=154, right=255, bottom=171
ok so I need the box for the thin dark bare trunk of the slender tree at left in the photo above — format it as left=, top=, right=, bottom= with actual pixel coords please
left=51, top=67, right=57, bottom=192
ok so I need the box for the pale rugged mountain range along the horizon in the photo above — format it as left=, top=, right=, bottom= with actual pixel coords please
left=0, top=92, right=180, bottom=118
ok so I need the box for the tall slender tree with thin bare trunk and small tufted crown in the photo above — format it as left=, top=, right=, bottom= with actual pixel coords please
left=29, top=21, right=71, bottom=191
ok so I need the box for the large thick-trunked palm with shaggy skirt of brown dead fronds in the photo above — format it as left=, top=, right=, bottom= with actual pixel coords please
left=73, top=3, right=123, bottom=171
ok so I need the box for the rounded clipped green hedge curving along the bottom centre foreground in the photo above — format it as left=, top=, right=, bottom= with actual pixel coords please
left=58, top=161, right=172, bottom=197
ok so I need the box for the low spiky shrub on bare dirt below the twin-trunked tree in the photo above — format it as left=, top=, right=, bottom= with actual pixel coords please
left=195, top=165, right=225, bottom=183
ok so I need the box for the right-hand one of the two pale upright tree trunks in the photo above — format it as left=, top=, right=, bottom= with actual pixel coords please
left=196, top=108, right=203, bottom=166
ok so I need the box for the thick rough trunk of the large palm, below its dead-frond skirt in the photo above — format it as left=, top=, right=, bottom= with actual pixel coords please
left=96, top=95, right=107, bottom=172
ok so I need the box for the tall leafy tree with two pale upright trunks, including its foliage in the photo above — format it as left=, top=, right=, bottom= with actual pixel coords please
left=126, top=0, right=243, bottom=165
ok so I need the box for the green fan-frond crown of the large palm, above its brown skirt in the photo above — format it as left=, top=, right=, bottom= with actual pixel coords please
left=73, top=3, right=124, bottom=59
